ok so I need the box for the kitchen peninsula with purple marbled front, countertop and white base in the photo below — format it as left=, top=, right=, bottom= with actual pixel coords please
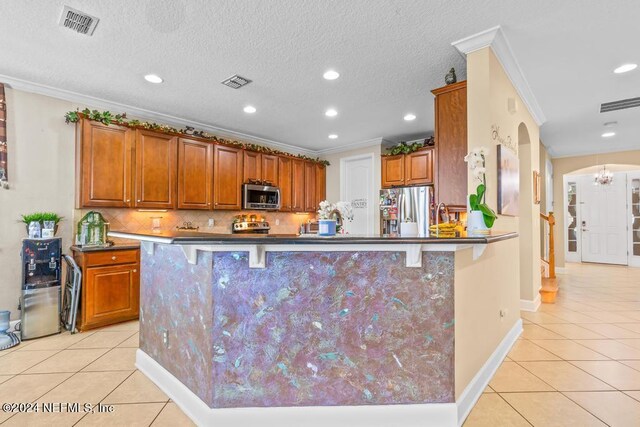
left=110, top=232, right=522, bottom=426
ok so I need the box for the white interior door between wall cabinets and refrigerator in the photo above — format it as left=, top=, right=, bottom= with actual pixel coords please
left=340, top=154, right=377, bottom=234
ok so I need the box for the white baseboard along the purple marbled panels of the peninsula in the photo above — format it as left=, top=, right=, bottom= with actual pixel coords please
left=136, top=349, right=458, bottom=427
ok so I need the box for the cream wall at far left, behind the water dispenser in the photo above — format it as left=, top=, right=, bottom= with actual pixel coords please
left=0, top=88, right=76, bottom=319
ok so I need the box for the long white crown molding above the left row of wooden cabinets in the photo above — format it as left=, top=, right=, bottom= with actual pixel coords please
left=0, top=74, right=320, bottom=156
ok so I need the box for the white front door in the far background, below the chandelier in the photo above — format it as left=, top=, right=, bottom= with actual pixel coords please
left=579, top=173, right=628, bottom=265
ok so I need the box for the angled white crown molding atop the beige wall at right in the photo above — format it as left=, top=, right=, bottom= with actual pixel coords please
left=451, top=25, right=547, bottom=126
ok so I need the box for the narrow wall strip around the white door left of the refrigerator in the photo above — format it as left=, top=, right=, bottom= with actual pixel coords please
left=323, top=144, right=382, bottom=234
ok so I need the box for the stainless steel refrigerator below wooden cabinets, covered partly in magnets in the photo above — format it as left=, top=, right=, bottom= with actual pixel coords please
left=380, top=186, right=433, bottom=236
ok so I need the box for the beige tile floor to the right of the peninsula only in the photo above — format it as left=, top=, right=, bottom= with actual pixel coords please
left=464, top=264, right=640, bottom=427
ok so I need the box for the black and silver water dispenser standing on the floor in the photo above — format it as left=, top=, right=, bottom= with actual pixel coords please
left=19, top=237, right=62, bottom=340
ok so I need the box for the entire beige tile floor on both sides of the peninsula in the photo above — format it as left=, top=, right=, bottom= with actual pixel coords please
left=5, top=265, right=640, bottom=427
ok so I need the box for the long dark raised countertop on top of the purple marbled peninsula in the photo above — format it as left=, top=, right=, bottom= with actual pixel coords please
left=109, top=230, right=518, bottom=245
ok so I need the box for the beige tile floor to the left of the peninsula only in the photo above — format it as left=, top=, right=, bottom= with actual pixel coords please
left=0, top=321, right=193, bottom=427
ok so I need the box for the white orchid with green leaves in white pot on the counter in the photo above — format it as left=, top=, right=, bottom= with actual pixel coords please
left=464, top=147, right=498, bottom=234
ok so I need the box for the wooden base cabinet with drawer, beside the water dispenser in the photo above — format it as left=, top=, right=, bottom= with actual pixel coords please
left=72, top=247, right=140, bottom=331
